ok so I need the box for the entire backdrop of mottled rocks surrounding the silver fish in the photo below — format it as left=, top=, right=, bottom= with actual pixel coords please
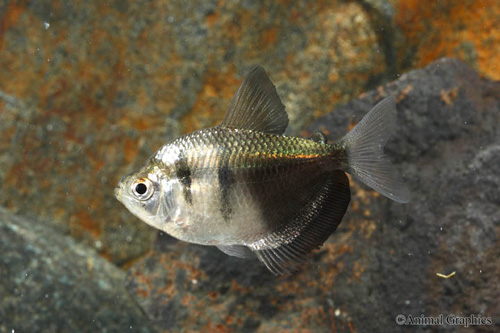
left=0, top=0, right=500, bottom=332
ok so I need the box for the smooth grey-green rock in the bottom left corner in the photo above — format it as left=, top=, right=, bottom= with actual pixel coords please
left=0, top=208, right=151, bottom=332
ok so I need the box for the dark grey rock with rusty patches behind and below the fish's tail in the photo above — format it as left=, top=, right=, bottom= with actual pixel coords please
left=128, top=59, right=500, bottom=332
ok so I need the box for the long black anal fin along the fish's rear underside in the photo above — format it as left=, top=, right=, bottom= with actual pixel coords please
left=250, top=171, right=351, bottom=275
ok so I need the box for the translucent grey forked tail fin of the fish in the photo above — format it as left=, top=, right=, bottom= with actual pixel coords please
left=342, top=96, right=410, bottom=203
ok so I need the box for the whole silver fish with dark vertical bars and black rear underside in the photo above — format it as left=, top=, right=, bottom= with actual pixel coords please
left=115, top=66, right=410, bottom=275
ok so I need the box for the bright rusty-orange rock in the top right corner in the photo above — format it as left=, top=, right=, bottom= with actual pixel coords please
left=394, top=0, right=500, bottom=80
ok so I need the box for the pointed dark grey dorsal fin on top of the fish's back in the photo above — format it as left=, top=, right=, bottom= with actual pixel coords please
left=221, top=66, right=288, bottom=134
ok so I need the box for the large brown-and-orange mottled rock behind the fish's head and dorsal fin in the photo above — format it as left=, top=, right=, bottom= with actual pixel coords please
left=0, top=0, right=386, bottom=264
